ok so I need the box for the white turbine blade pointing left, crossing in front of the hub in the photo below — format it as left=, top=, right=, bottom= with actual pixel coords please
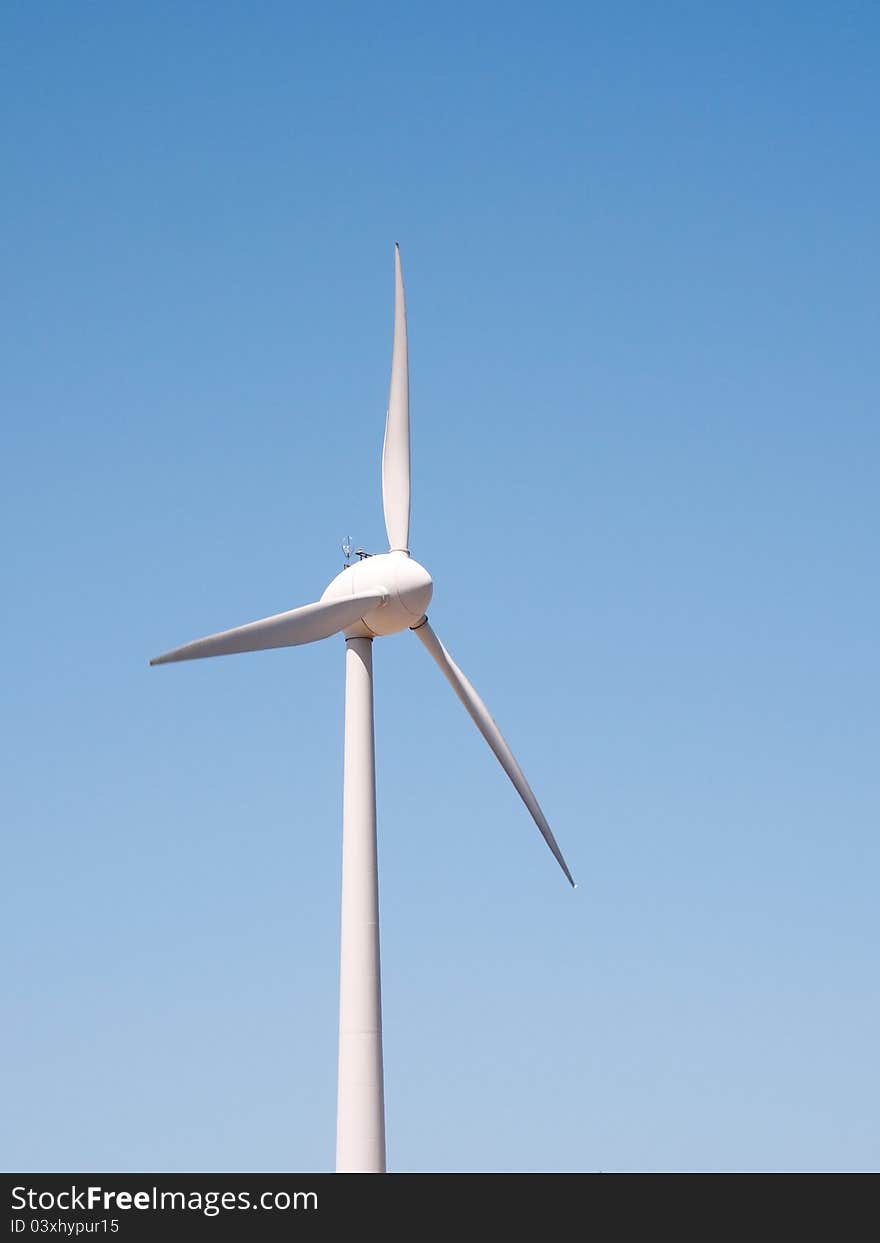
left=150, top=590, right=385, bottom=665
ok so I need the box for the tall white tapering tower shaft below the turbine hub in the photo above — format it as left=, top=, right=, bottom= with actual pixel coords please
left=336, top=639, right=385, bottom=1173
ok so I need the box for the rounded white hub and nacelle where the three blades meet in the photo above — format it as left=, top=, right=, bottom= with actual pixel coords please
left=321, top=552, right=434, bottom=639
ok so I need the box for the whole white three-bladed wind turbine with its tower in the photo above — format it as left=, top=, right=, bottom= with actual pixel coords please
left=150, top=245, right=574, bottom=1173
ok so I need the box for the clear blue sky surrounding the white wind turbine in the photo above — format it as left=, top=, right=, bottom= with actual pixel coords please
left=0, top=2, right=880, bottom=1171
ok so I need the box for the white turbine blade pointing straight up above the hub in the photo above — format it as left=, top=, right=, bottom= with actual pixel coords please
left=382, top=242, right=409, bottom=552
